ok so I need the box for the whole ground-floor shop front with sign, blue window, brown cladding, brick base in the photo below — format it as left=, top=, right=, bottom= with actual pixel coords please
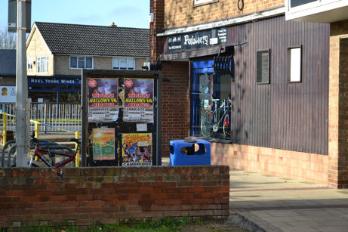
left=158, top=15, right=329, bottom=184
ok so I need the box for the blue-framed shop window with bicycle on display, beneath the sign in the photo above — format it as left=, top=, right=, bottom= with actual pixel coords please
left=191, top=60, right=232, bottom=139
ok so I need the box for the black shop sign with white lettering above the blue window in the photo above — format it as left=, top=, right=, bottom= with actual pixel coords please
left=167, top=28, right=227, bottom=52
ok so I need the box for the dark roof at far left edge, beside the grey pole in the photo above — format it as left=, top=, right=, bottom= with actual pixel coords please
left=0, top=49, right=16, bottom=76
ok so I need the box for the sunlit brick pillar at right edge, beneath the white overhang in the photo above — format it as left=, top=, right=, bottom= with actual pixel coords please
left=329, top=21, right=348, bottom=188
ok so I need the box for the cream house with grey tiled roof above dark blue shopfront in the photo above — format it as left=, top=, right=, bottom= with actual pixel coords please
left=27, top=22, right=150, bottom=103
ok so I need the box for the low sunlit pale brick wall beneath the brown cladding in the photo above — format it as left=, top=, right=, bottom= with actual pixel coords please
left=212, top=143, right=328, bottom=185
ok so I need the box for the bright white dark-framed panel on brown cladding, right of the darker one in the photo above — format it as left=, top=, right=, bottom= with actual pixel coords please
left=289, top=47, right=302, bottom=83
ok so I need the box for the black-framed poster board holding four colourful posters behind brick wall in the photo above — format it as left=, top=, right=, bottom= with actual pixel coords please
left=81, top=70, right=161, bottom=167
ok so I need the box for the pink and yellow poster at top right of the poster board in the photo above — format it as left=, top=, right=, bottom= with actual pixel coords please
left=123, top=79, right=154, bottom=123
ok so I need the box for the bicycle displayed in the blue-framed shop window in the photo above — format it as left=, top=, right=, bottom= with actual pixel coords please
left=201, top=98, right=232, bottom=138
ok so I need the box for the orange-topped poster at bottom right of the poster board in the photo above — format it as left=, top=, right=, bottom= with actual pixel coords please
left=122, top=133, right=152, bottom=166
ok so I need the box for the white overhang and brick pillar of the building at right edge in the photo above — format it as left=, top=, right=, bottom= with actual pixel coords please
left=285, top=0, right=348, bottom=188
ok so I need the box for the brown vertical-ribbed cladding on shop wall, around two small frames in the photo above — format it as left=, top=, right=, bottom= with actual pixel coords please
left=229, top=17, right=330, bottom=154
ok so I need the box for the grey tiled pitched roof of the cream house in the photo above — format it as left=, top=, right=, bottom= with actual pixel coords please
left=35, top=22, right=150, bottom=57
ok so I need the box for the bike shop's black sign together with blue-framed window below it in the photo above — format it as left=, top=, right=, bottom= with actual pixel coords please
left=163, top=28, right=235, bottom=140
